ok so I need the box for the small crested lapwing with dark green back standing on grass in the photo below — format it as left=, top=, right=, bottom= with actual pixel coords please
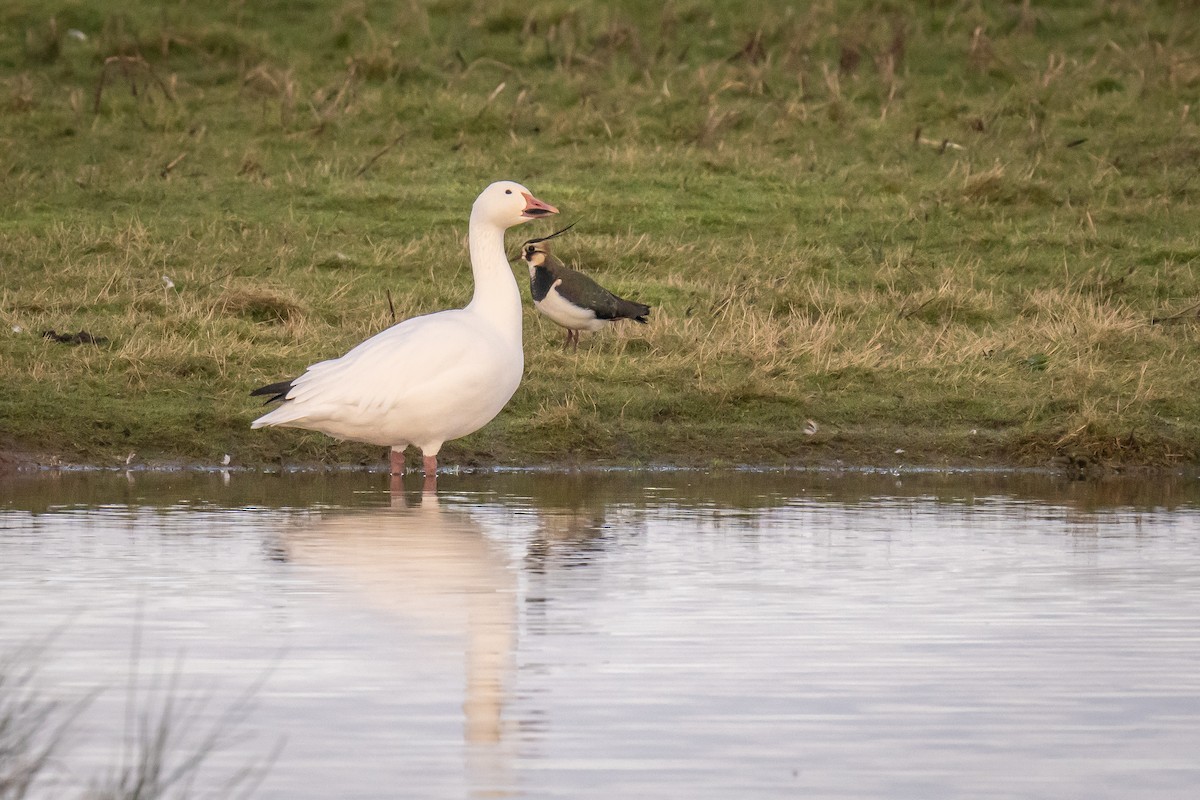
left=521, top=223, right=650, bottom=349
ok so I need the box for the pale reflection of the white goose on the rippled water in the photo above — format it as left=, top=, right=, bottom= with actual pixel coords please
left=286, top=494, right=516, bottom=744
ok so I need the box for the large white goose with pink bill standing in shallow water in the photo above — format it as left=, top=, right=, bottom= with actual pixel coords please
left=250, top=181, right=558, bottom=481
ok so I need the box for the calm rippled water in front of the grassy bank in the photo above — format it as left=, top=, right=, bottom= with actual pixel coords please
left=0, top=473, right=1200, bottom=800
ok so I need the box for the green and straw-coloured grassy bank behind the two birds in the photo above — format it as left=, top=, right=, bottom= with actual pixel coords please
left=0, top=0, right=1200, bottom=472
